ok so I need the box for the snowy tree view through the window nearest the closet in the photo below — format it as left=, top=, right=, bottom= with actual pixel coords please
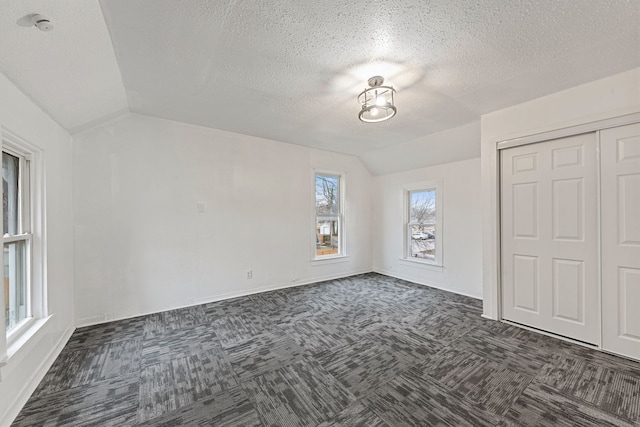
left=407, top=189, right=436, bottom=261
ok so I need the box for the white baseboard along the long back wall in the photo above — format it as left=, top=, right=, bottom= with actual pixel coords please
left=77, top=269, right=372, bottom=328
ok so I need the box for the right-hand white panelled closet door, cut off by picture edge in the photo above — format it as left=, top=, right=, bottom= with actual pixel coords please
left=600, top=124, right=640, bottom=359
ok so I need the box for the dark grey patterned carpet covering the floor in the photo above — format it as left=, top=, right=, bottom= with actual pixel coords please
left=14, top=273, right=640, bottom=427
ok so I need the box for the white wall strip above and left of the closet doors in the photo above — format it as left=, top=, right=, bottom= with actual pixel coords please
left=481, top=68, right=640, bottom=319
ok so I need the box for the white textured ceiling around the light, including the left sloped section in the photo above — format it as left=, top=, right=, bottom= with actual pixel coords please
left=0, top=0, right=640, bottom=158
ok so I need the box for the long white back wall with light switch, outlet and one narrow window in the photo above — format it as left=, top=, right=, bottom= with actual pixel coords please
left=74, top=115, right=371, bottom=325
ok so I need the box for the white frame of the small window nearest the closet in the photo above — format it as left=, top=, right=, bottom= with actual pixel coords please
left=402, top=180, right=444, bottom=267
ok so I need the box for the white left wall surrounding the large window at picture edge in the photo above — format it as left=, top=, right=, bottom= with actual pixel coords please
left=0, top=74, right=75, bottom=425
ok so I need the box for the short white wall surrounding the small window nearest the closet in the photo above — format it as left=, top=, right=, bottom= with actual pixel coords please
left=372, top=158, right=482, bottom=298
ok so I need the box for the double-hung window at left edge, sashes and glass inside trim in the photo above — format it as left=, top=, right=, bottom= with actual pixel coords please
left=2, top=149, right=31, bottom=332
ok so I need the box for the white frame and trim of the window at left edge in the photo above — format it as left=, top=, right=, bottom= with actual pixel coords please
left=0, top=127, right=47, bottom=356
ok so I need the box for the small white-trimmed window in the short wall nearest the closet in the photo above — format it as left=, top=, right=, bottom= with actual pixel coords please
left=405, top=184, right=442, bottom=265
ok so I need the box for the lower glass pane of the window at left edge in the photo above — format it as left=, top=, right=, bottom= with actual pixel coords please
left=4, top=241, right=29, bottom=331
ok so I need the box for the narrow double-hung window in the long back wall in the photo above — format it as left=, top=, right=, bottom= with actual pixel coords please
left=315, top=174, right=343, bottom=258
